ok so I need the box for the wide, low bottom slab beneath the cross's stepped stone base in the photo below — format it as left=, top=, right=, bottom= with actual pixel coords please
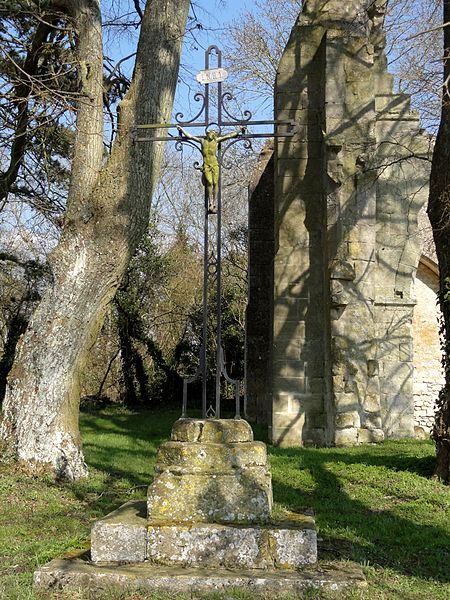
left=33, top=556, right=367, bottom=597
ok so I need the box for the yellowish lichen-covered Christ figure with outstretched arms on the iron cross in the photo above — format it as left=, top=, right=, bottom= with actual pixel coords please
left=177, top=125, right=246, bottom=214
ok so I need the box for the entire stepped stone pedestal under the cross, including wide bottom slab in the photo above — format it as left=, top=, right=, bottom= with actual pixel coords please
left=34, top=419, right=364, bottom=593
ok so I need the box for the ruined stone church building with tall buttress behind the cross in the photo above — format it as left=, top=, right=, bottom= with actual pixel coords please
left=247, top=0, right=442, bottom=445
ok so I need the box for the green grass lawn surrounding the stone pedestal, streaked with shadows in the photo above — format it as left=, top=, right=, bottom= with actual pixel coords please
left=0, top=411, right=450, bottom=600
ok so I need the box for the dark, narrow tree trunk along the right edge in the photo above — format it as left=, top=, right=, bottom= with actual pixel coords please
left=428, top=0, right=450, bottom=483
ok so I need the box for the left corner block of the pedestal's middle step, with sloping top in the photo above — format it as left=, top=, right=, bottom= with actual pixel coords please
left=91, top=500, right=147, bottom=563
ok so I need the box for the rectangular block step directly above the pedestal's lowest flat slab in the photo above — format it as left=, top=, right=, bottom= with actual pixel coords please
left=91, top=501, right=317, bottom=569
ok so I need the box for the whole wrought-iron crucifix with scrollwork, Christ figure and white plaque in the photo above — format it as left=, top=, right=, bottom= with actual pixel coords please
left=132, top=46, right=296, bottom=419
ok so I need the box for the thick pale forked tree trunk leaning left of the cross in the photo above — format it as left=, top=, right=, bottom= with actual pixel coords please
left=1, top=0, right=189, bottom=479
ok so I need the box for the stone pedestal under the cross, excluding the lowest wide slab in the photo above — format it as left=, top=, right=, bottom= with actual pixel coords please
left=91, top=419, right=317, bottom=569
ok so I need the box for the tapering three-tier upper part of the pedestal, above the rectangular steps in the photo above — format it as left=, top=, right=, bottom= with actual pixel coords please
left=147, top=419, right=272, bottom=525
